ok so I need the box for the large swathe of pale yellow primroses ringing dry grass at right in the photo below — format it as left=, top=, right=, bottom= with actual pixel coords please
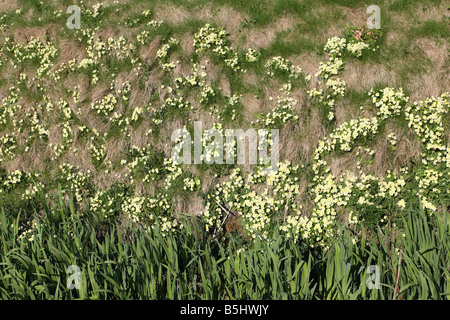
left=287, top=88, right=450, bottom=246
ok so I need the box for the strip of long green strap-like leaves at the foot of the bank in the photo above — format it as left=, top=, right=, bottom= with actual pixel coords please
left=0, top=192, right=450, bottom=300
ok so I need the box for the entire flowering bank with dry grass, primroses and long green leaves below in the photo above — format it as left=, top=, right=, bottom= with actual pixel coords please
left=0, top=0, right=450, bottom=300
